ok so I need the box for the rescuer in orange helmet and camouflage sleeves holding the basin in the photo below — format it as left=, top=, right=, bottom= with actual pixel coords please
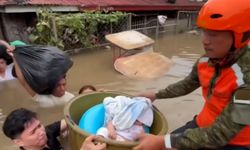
left=134, top=0, right=250, bottom=150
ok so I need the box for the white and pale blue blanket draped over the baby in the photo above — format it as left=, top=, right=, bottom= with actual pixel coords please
left=103, top=96, right=153, bottom=130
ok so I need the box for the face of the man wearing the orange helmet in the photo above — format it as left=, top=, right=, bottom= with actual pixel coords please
left=202, top=29, right=233, bottom=59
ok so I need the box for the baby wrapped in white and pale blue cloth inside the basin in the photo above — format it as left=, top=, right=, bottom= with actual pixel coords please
left=97, top=96, right=153, bottom=141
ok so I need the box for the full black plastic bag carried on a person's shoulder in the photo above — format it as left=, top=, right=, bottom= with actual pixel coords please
left=14, top=45, right=73, bottom=94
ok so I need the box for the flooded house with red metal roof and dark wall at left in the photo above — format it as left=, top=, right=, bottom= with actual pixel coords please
left=0, top=0, right=205, bottom=42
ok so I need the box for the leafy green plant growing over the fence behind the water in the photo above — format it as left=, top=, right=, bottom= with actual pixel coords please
left=30, top=10, right=127, bottom=50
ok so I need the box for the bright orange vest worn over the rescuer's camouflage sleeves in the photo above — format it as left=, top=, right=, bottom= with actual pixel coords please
left=196, top=57, right=250, bottom=146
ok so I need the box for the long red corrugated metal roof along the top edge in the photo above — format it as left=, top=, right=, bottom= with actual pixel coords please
left=0, top=0, right=203, bottom=10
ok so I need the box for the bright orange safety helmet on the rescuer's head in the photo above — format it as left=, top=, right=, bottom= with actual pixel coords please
left=197, top=0, right=250, bottom=48
